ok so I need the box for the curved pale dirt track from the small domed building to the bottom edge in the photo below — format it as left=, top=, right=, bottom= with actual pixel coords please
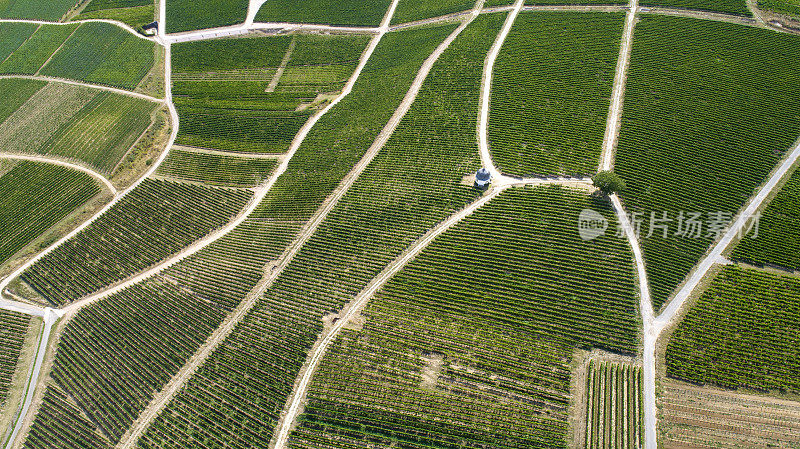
left=270, top=186, right=510, bottom=449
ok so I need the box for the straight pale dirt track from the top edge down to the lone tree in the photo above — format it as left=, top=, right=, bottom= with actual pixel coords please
left=599, top=0, right=639, bottom=171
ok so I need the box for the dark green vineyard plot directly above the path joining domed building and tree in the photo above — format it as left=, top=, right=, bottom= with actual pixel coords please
left=488, top=12, right=625, bottom=177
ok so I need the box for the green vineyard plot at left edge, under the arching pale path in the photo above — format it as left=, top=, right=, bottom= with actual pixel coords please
left=0, top=161, right=100, bottom=265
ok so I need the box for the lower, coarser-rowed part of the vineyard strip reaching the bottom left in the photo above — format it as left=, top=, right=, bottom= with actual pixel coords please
left=25, top=211, right=301, bottom=449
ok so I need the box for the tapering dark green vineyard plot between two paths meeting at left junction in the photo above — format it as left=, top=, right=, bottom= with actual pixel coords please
left=20, top=180, right=252, bottom=306
